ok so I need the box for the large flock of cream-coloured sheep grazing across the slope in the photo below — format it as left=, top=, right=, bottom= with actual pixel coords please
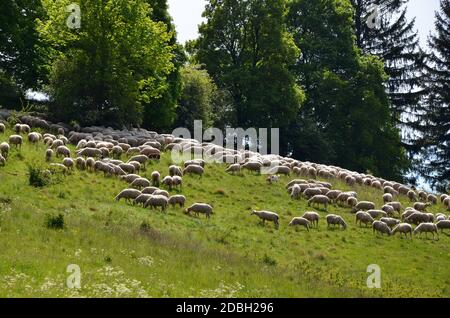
left=0, top=114, right=450, bottom=238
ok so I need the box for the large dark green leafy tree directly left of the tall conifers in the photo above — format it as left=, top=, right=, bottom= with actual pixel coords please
left=288, top=0, right=407, bottom=180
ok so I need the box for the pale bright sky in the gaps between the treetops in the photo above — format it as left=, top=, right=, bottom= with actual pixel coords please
left=169, top=0, right=439, bottom=46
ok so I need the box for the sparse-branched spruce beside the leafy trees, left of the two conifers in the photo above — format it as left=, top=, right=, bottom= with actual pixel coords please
left=351, top=0, right=425, bottom=153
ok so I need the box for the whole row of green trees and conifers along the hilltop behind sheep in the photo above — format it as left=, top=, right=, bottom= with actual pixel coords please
left=0, top=0, right=450, bottom=190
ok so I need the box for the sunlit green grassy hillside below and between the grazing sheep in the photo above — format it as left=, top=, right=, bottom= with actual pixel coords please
left=0, top=131, right=450, bottom=297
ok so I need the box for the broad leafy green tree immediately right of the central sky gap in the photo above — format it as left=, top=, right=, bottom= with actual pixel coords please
left=194, top=0, right=303, bottom=150
